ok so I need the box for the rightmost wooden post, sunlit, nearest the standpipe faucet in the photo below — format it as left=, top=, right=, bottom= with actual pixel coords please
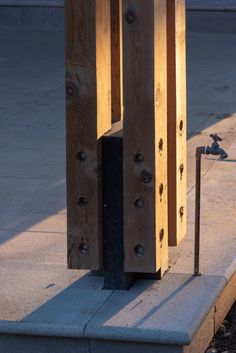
left=167, top=0, right=187, bottom=246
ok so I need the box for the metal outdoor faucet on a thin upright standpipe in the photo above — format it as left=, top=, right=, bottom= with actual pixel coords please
left=194, top=134, right=228, bottom=276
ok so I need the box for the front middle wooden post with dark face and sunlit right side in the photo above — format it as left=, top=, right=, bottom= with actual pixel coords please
left=123, top=0, right=168, bottom=274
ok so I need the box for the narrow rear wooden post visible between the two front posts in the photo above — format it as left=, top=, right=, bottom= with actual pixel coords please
left=110, top=0, right=123, bottom=122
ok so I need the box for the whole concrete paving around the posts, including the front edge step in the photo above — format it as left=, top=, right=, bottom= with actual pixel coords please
left=0, top=15, right=236, bottom=353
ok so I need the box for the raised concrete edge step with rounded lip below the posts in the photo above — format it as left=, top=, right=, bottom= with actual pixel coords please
left=0, top=273, right=236, bottom=353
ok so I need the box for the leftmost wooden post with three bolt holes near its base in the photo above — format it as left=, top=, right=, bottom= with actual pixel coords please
left=65, top=0, right=111, bottom=270
